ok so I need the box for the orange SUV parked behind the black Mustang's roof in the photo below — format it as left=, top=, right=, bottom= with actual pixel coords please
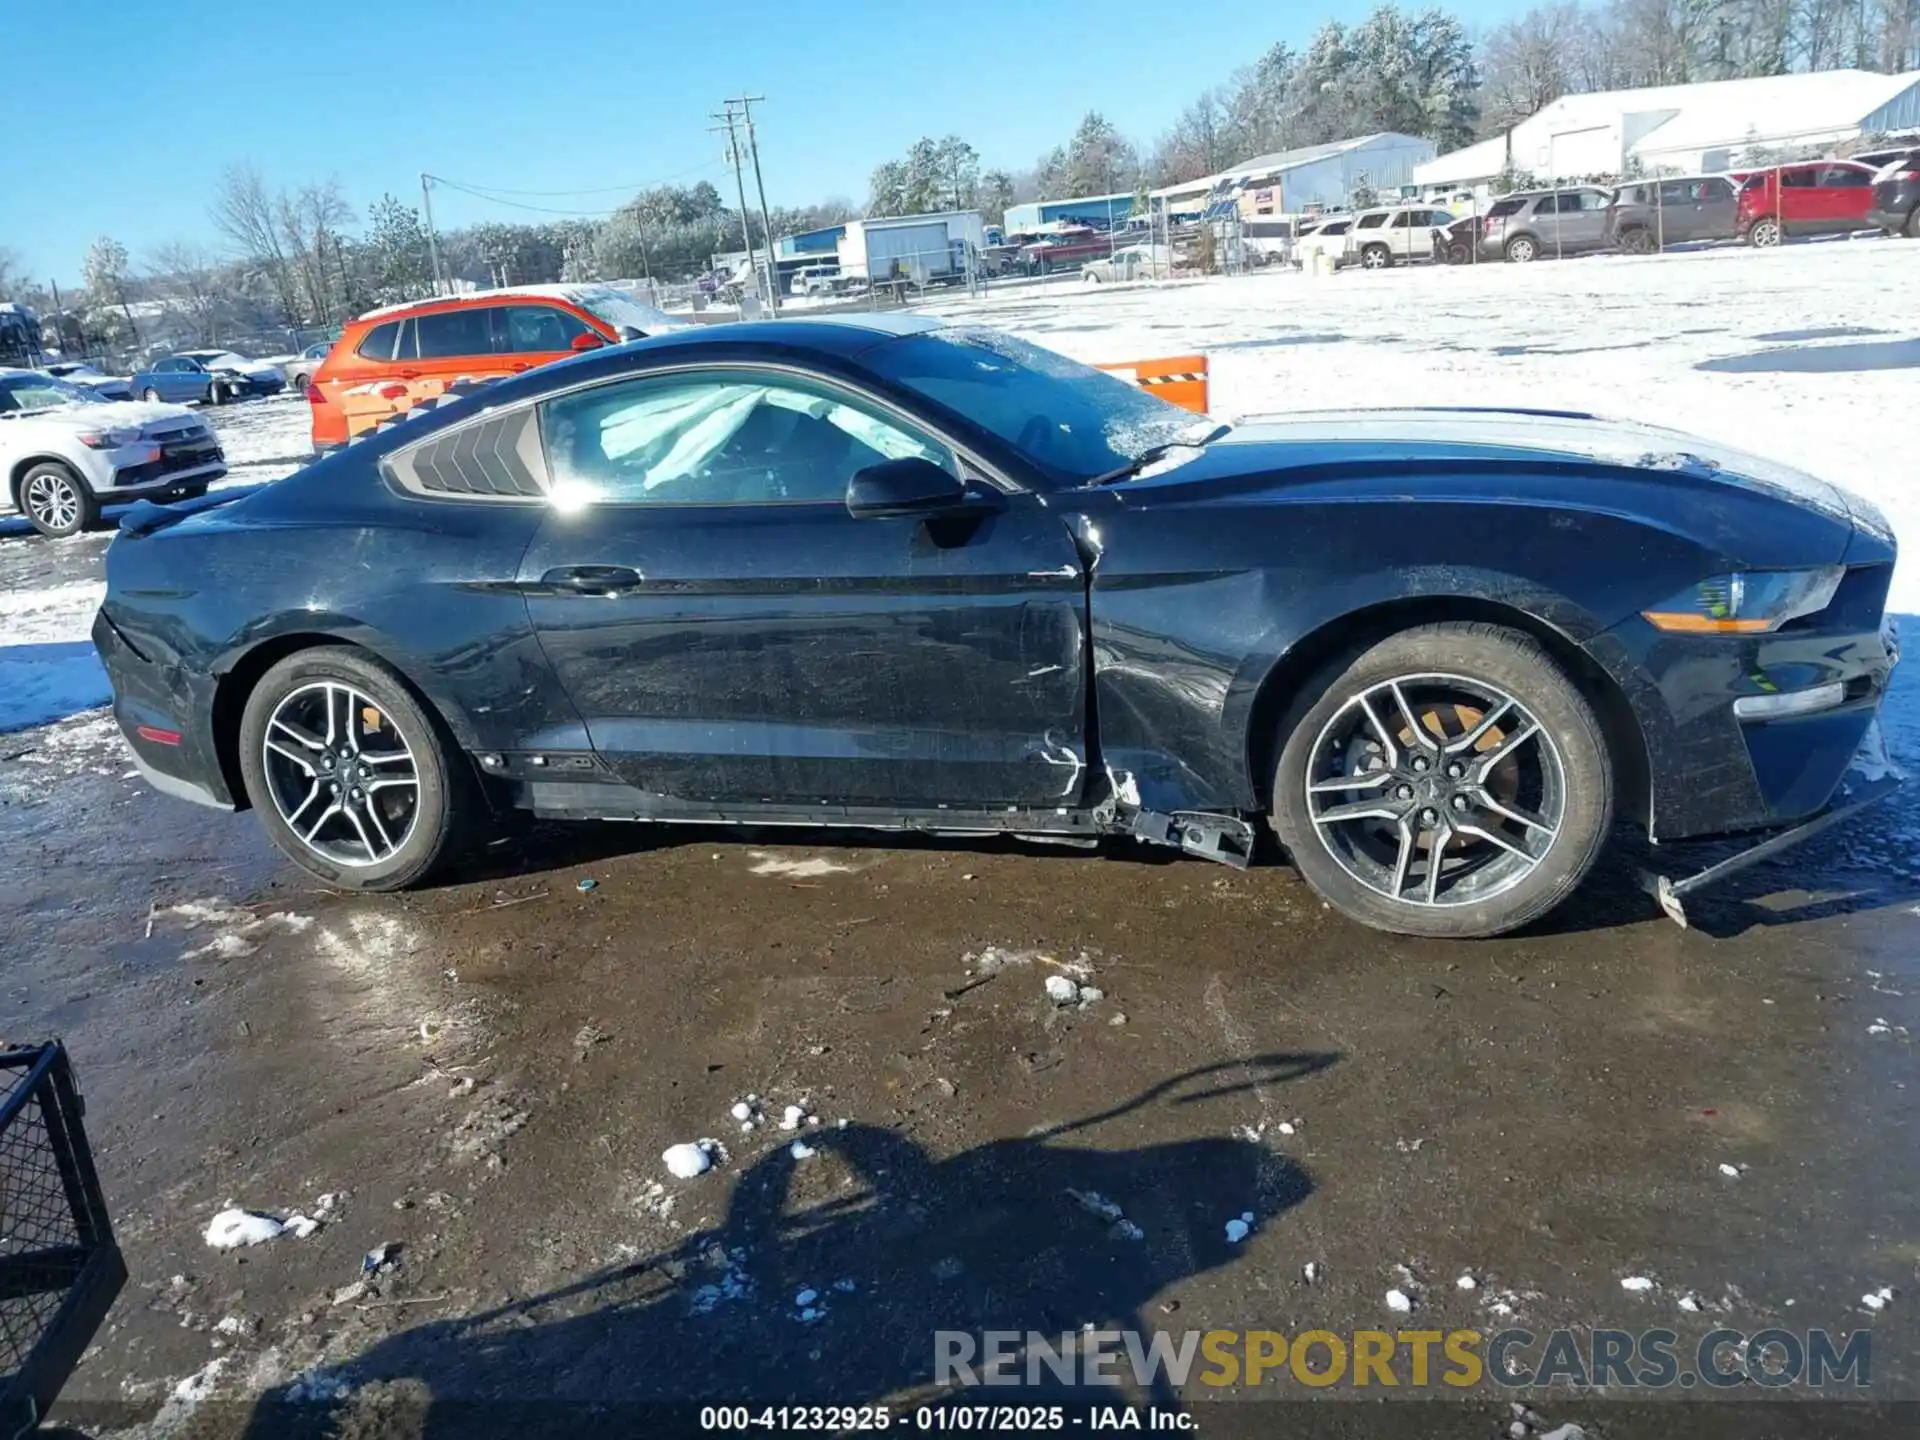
left=307, top=284, right=685, bottom=455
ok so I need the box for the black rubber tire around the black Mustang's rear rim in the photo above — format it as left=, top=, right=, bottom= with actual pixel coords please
left=240, top=645, right=482, bottom=891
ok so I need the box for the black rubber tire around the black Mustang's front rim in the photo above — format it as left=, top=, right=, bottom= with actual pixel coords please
left=1273, top=620, right=1613, bottom=939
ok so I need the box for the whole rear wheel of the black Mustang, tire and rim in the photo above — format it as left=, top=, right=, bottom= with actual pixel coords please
left=240, top=645, right=476, bottom=891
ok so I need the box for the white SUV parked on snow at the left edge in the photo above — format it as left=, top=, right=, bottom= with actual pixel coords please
left=0, top=369, right=227, bottom=536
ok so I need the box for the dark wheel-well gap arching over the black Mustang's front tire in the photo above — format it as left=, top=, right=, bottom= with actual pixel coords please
left=1246, top=595, right=1651, bottom=824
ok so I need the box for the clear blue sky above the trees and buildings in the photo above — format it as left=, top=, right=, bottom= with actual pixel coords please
left=0, top=0, right=1521, bottom=284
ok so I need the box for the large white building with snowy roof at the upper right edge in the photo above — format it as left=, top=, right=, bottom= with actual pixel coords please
left=1413, top=69, right=1920, bottom=198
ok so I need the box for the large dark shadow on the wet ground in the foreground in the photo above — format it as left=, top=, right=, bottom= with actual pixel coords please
left=232, top=1052, right=1338, bottom=1440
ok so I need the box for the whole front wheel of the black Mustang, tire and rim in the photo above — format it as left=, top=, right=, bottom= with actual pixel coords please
left=1273, top=622, right=1613, bottom=939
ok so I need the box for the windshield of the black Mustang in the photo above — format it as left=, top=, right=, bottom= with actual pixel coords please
left=862, top=328, right=1200, bottom=486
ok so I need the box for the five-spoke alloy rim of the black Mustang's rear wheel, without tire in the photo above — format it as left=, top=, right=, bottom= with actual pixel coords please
left=261, top=680, right=420, bottom=866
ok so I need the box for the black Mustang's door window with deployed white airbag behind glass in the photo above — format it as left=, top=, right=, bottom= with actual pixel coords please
left=540, top=371, right=962, bottom=507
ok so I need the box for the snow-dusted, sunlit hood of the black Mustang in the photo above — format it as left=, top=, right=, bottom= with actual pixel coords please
left=1208, top=409, right=1893, bottom=540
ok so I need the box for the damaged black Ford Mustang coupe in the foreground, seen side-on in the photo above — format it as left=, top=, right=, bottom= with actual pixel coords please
left=94, top=317, right=1895, bottom=935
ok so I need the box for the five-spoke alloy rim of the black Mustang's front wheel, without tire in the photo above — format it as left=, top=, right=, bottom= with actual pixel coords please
left=1306, top=674, right=1567, bottom=906
